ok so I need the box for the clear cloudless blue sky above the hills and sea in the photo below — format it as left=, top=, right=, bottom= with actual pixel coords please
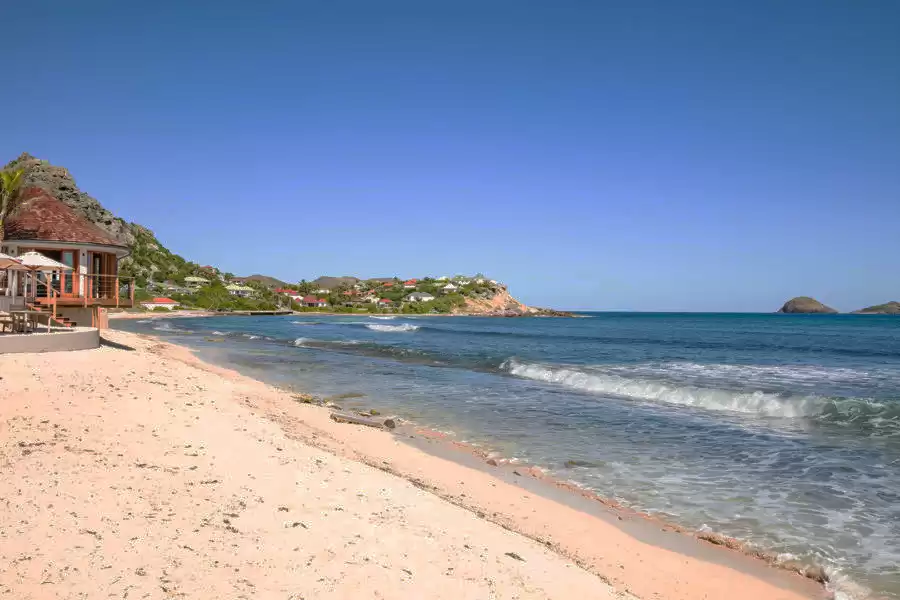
left=0, top=0, right=900, bottom=311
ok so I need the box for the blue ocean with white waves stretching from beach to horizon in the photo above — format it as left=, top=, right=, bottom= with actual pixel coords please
left=113, top=313, right=900, bottom=598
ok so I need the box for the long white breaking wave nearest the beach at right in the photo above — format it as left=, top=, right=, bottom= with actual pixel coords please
left=501, top=359, right=900, bottom=428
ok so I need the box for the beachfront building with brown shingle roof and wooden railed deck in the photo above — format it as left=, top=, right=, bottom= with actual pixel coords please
left=0, top=187, right=134, bottom=327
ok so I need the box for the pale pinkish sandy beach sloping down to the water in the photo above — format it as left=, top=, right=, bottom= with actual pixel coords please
left=0, top=331, right=826, bottom=600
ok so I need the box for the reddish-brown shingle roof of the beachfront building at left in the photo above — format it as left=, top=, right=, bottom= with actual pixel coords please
left=4, top=187, right=125, bottom=247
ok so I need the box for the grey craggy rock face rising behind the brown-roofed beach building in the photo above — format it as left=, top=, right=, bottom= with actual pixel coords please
left=5, top=152, right=134, bottom=246
